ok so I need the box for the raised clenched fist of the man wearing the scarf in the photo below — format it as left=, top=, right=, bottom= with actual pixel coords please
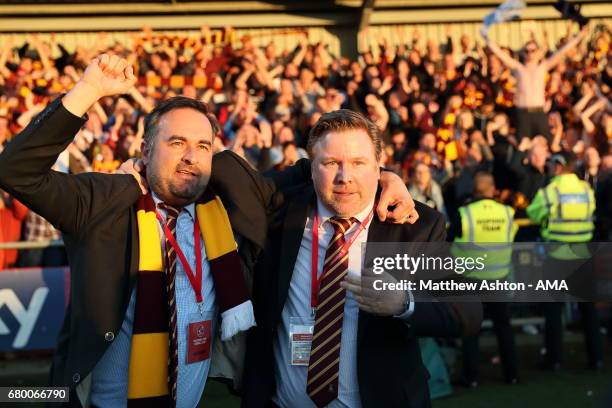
left=62, top=54, right=136, bottom=116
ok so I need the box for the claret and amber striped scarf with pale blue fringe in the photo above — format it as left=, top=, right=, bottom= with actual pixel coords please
left=128, top=188, right=255, bottom=407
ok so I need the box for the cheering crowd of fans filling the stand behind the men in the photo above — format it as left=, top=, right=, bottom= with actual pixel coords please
left=0, top=25, right=612, bottom=267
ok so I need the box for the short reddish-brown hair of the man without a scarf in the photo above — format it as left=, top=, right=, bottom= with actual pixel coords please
left=306, top=109, right=382, bottom=161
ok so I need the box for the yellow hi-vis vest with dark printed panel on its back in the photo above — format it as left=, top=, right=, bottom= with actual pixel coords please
left=452, top=199, right=517, bottom=280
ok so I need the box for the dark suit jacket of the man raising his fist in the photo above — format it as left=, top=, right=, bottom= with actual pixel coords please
left=0, top=98, right=309, bottom=404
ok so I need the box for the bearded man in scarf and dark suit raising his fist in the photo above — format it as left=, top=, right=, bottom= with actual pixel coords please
left=0, top=55, right=416, bottom=408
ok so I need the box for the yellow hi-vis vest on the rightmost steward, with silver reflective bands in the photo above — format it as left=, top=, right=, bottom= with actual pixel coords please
left=542, top=174, right=595, bottom=242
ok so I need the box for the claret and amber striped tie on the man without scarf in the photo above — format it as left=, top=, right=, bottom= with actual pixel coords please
left=306, top=217, right=357, bottom=407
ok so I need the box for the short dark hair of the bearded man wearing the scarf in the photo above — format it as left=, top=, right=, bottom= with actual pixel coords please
left=144, top=96, right=221, bottom=148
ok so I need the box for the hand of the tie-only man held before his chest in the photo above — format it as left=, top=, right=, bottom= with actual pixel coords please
left=340, top=272, right=408, bottom=316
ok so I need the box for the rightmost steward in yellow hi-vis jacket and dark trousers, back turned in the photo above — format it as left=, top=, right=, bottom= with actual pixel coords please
left=527, top=152, right=603, bottom=370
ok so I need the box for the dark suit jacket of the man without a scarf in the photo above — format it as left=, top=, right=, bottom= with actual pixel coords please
left=243, top=184, right=482, bottom=408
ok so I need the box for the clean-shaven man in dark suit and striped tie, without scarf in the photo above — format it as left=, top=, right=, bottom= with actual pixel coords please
left=243, top=110, right=482, bottom=408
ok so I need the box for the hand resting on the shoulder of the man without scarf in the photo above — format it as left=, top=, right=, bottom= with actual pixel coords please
left=376, top=171, right=419, bottom=224
